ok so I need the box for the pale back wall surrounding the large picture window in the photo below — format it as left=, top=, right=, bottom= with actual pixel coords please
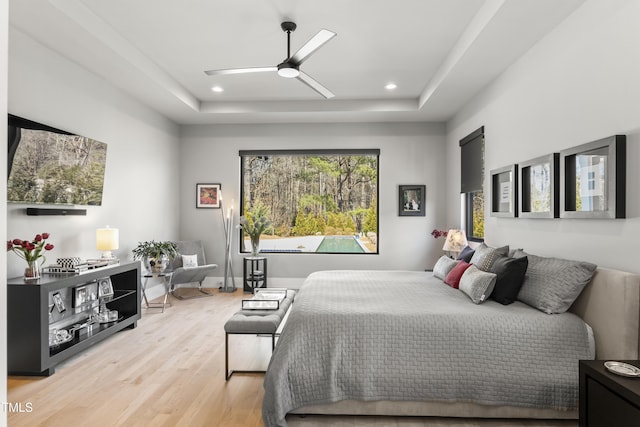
left=180, top=123, right=448, bottom=286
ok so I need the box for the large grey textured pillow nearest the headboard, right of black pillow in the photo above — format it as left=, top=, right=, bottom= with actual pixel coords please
left=514, top=251, right=597, bottom=314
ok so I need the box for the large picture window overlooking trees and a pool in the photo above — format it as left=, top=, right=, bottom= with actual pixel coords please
left=239, top=150, right=380, bottom=254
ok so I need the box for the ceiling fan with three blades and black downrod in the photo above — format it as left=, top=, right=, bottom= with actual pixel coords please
left=205, top=21, right=336, bottom=99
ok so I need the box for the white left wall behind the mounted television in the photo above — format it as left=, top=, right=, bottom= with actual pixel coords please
left=3, top=28, right=180, bottom=277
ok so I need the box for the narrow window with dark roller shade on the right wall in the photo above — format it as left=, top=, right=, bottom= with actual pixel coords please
left=460, top=126, right=484, bottom=241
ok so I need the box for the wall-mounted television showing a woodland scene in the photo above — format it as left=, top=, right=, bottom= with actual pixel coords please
left=7, top=114, right=107, bottom=205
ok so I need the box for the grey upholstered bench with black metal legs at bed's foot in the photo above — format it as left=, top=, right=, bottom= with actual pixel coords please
left=224, top=289, right=296, bottom=380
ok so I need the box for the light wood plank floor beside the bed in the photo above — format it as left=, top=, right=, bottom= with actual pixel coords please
left=8, top=290, right=578, bottom=427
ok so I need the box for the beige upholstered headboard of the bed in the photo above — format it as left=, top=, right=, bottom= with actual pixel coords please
left=569, top=268, right=640, bottom=360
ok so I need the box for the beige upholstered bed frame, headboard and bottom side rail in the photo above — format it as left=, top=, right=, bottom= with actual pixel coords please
left=291, top=268, right=640, bottom=419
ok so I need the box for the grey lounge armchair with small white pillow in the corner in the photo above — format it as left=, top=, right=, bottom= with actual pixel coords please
left=169, top=240, right=218, bottom=299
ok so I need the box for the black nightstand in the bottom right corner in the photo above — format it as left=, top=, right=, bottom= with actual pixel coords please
left=579, top=360, right=640, bottom=427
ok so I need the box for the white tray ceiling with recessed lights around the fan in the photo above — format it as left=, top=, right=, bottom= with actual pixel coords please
left=9, top=0, right=584, bottom=124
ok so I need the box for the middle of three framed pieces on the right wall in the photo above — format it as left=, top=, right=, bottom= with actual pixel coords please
left=519, top=153, right=560, bottom=218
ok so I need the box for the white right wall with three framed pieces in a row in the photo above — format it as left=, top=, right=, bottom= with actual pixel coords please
left=447, top=0, right=640, bottom=272
